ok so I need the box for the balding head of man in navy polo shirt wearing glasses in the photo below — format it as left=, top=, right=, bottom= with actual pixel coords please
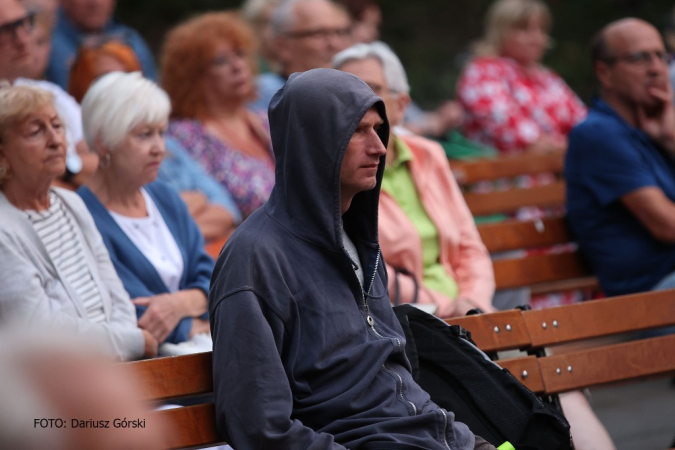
left=596, top=20, right=669, bottom=109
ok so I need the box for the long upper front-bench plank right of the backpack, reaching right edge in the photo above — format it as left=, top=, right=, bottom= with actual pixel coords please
left=522, top=289, right=675, bottom=348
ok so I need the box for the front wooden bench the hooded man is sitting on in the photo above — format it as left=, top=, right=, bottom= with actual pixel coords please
left=125, top=290, right=675, bottom=448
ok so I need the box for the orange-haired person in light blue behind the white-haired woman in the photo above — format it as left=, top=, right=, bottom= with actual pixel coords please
left=68, top=41, right=241, bottom=241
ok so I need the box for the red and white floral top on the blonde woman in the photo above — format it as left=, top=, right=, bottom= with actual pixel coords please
left=457, top=57, right=586, bottom=152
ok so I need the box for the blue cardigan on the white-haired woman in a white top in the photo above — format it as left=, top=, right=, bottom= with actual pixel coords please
left=77, top=182, right=213, bottom=344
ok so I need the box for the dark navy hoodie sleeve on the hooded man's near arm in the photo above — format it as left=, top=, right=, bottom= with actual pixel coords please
left=211, top=291, right=346, bottom=450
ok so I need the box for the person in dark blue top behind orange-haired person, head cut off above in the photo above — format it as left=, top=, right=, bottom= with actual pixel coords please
left=47, top=0, right=157, bottom=89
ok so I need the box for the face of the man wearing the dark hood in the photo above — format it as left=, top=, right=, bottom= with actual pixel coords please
left=340, top=107, right=387, bottom=198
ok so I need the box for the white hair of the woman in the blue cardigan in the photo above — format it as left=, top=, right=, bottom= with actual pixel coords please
left=82, top=72, right=171, bottom=151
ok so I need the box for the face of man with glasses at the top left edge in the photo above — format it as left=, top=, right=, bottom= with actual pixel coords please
left=0, top=0, right=33, bottom=81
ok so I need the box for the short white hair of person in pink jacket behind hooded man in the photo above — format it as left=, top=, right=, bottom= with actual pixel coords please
left=333, top=41, right=410, bottom=94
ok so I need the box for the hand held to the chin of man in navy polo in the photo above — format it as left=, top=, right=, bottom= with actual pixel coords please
left=637, top=83, right=675, bottom=155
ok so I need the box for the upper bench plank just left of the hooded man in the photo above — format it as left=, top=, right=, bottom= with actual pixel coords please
left=126, top=352, right=213, bottom=400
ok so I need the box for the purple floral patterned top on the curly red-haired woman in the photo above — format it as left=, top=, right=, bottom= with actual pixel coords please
left=166, top=116, right=274, bottom=218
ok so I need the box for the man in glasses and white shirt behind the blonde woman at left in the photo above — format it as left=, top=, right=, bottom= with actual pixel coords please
left=0, top=0, right=98, bottom=186
